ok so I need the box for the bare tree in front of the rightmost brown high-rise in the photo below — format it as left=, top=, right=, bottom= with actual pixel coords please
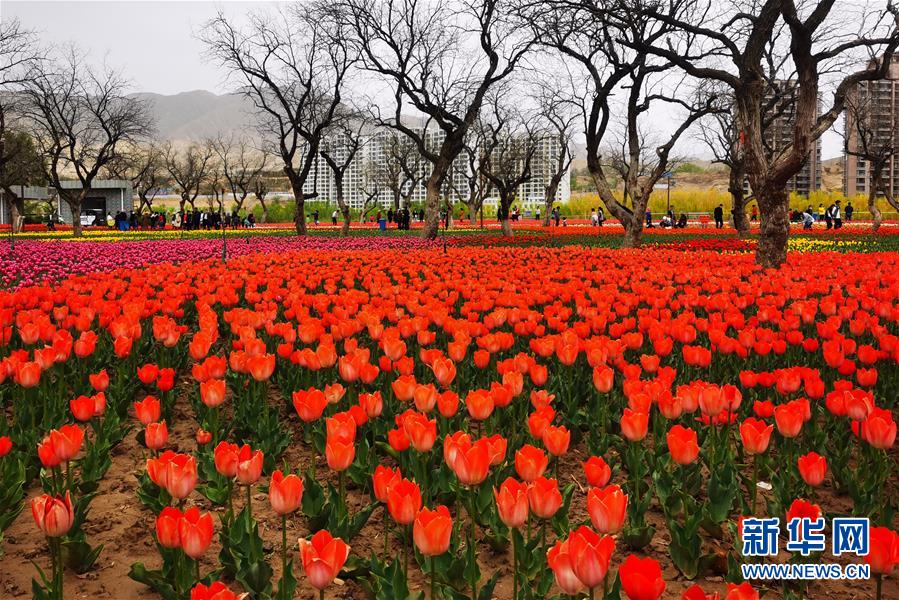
left=843, top=74, right=899, bottom=231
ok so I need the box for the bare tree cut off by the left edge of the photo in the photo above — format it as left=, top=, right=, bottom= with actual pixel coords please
left=0, top=19, right=41, bottom=233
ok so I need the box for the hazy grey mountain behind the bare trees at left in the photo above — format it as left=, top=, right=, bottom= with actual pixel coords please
left=134, top=90, right=253, bottom=141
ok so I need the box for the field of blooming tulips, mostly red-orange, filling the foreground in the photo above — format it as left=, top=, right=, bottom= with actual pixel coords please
left=0, top=228, right=899, bottom=600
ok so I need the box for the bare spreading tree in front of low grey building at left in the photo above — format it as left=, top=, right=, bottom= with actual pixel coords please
left=25, top=48, right=152, bottom=237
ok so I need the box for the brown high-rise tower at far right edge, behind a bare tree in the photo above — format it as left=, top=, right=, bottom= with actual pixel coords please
left=843, top=62, right=899, bottom=198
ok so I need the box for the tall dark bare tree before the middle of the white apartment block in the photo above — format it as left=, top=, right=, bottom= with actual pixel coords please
left=341, top=0, right=531, bottom=238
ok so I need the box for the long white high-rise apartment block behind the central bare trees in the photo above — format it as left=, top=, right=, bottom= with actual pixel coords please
left=304, top=118, right=571, bottom=210
